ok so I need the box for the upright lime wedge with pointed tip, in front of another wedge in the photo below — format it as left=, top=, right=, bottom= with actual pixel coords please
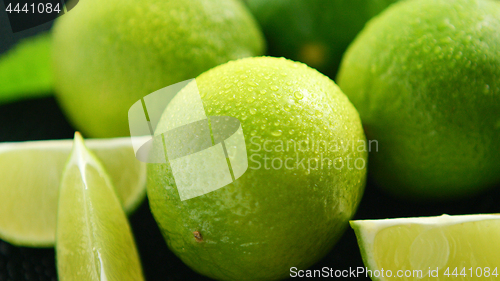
left=56, top=133, right=144, bottom=281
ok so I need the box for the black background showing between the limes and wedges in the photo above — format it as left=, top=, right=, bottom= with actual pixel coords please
left=0, top=1, right=500, bottom=281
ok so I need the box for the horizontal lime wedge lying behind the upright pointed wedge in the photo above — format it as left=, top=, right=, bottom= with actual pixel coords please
left=0, top=135, right=146, bottom=244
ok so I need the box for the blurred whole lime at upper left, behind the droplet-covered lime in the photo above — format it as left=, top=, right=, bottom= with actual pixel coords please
left=53, top=0, right=264, bottom=137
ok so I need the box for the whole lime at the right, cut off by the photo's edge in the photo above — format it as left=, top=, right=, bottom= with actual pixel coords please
left=338, top=0, right=500, bottom=199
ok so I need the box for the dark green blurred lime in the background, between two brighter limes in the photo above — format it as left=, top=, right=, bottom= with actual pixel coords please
left=245, top=0, right=397, bottom=79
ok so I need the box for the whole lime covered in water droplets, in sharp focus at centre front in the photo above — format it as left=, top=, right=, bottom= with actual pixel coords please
left=148, top=57, right=367, bottom=280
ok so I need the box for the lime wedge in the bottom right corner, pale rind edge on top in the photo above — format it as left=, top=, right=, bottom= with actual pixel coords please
left=351, top=214, right=500, bottom=281
